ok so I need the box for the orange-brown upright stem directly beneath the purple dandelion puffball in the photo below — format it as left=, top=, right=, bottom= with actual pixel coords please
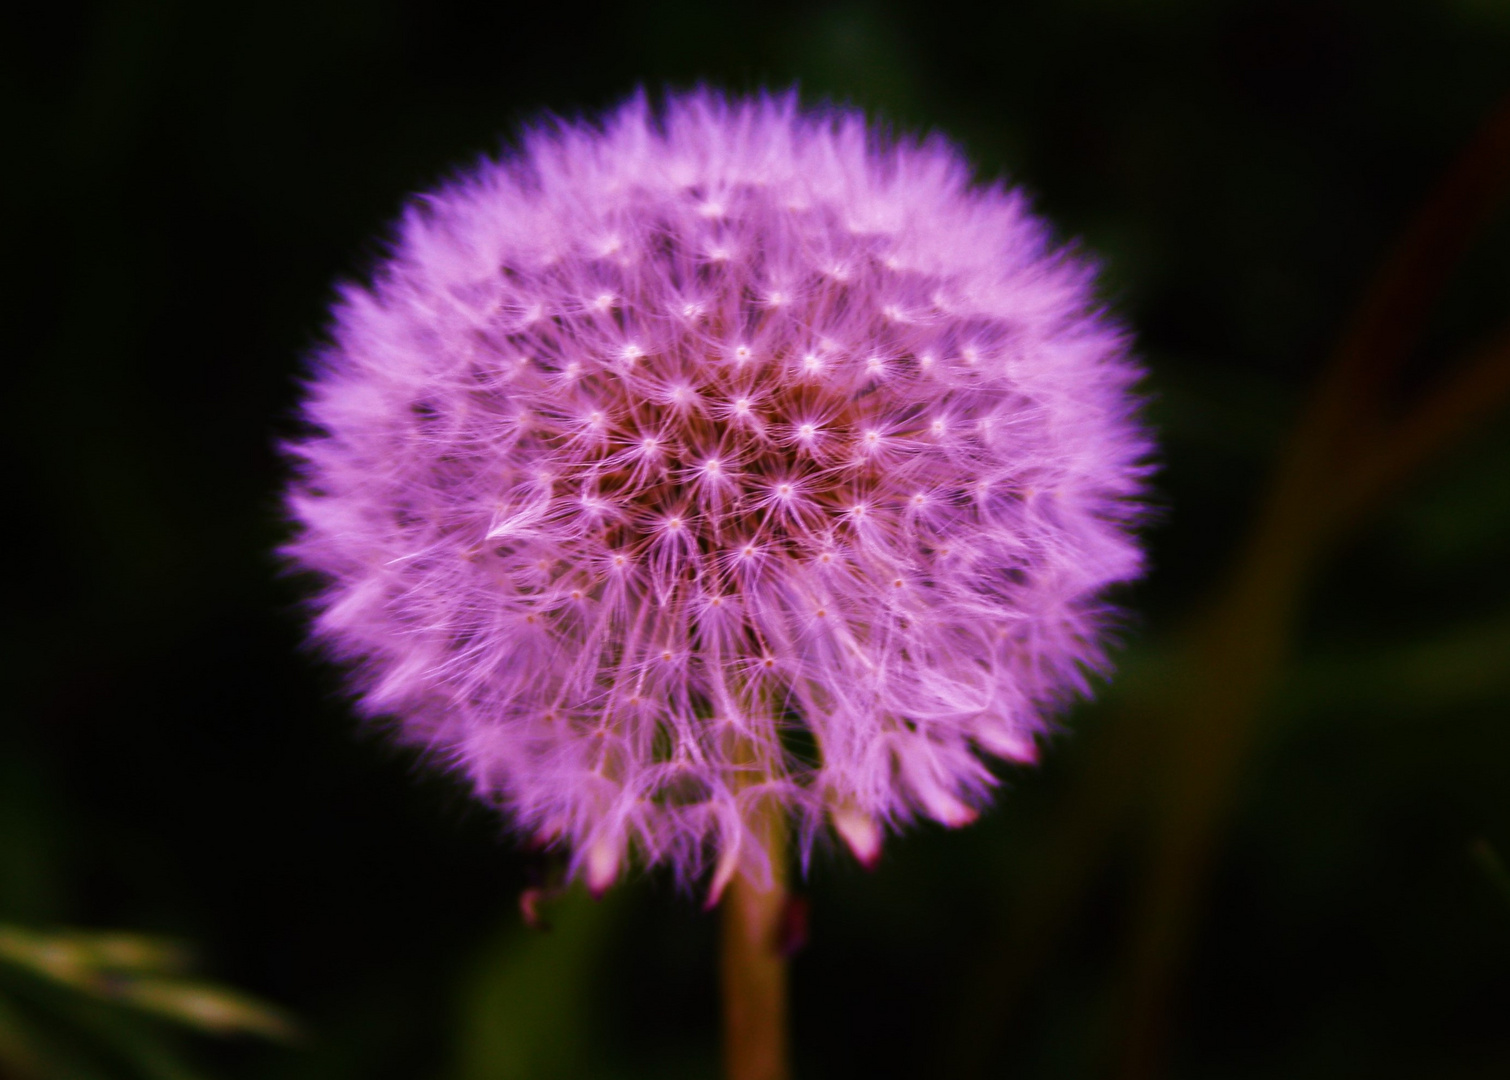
left=720, top=829, right=791, bottom=1080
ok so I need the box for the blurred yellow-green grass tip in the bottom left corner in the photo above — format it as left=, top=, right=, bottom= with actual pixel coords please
left=0, top=924, right=299, bottom=1080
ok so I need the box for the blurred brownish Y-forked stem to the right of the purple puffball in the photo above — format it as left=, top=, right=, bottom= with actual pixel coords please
left=1119, top=91, right=1510, bottom=1080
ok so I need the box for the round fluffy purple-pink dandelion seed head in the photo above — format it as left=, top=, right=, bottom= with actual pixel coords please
left=285, top=91, right=1149, bottom=897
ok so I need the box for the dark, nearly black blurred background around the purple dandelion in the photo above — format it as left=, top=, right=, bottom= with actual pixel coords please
left=0, top=0, right=1510, bottom=1080
